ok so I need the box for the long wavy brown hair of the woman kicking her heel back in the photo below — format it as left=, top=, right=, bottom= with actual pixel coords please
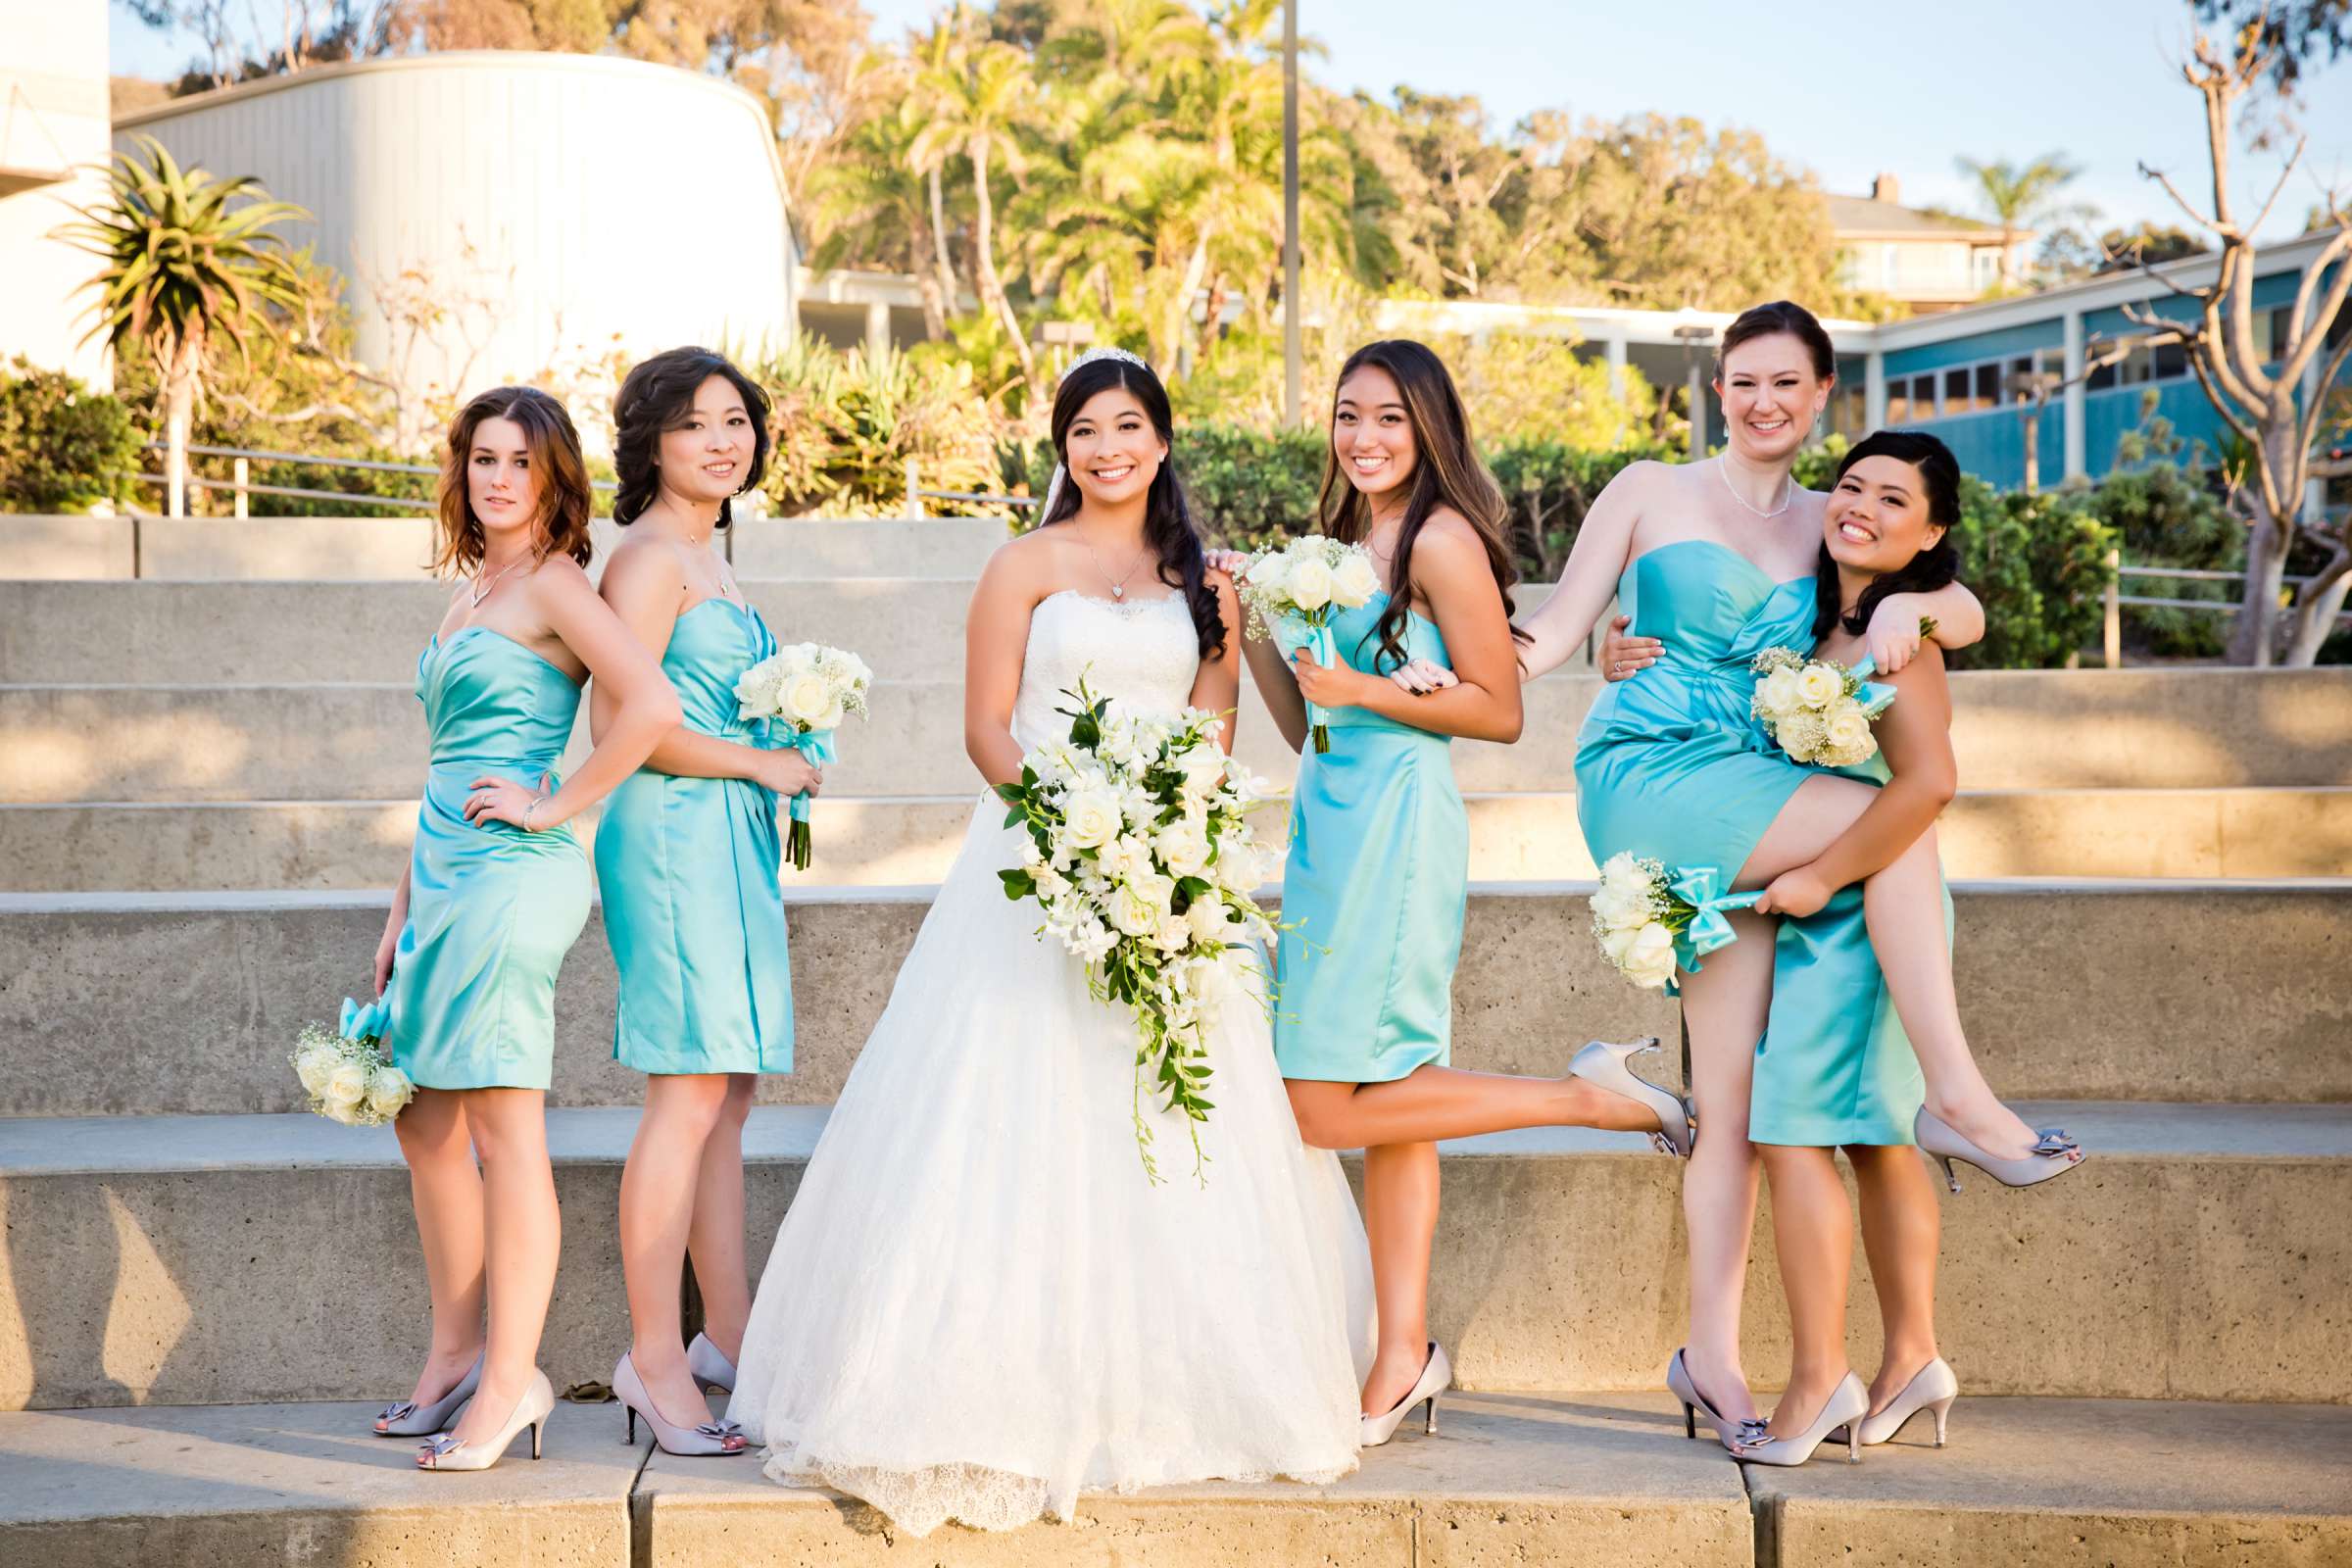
left=1315, top=338, right=1527, bottom=667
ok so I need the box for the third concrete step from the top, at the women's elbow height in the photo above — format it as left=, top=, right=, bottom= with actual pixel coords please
left=18, top=667, right=2352, bottom=802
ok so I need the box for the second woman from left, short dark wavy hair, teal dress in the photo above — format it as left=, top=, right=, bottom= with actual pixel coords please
left=588, top=348, right=821, bottom=1455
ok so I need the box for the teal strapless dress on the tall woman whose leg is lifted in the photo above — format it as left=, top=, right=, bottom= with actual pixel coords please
left=1576, top=538, right=1813, bottom=906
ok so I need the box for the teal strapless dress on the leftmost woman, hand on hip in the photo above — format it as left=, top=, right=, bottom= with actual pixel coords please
left=383, top=625, right=590, bottom=1089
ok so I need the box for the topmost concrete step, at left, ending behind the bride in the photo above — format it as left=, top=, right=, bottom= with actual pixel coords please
left=0, top=517, right=1009, bottom=583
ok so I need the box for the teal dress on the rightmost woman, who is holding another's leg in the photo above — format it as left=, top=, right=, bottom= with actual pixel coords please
left=1747, top=659, right=1952, bottom=1150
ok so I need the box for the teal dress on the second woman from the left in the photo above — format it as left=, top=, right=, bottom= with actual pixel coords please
left=595, top=600, right=793, bottom=1072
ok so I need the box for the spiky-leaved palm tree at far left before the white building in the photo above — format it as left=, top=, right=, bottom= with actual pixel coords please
left=57, top=136, right=311, bottom=517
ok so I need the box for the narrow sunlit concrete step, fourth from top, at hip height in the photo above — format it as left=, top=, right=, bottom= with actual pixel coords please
left=0, top=788, right=2352, bottom=894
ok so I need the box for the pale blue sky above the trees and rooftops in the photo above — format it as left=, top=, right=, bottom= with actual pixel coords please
left=111, top=0, right=2352, bottom=232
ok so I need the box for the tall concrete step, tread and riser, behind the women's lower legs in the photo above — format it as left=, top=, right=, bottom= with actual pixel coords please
left=0, top=1102, right=2352, bottom=1408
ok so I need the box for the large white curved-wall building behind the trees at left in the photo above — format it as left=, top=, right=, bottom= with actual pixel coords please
left=116, top=49, right=795, bottom=441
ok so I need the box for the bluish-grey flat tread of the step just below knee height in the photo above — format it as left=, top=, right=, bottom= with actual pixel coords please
left=0, top=1101, right=2352, bottom=1187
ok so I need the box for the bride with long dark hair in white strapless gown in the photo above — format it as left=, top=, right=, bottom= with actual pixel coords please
left=727, top=350, right=1371, bottom=1535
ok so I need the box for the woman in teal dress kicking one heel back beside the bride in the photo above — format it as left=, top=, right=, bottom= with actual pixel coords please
left=1218, top=338, right=1689, bottom=1444
